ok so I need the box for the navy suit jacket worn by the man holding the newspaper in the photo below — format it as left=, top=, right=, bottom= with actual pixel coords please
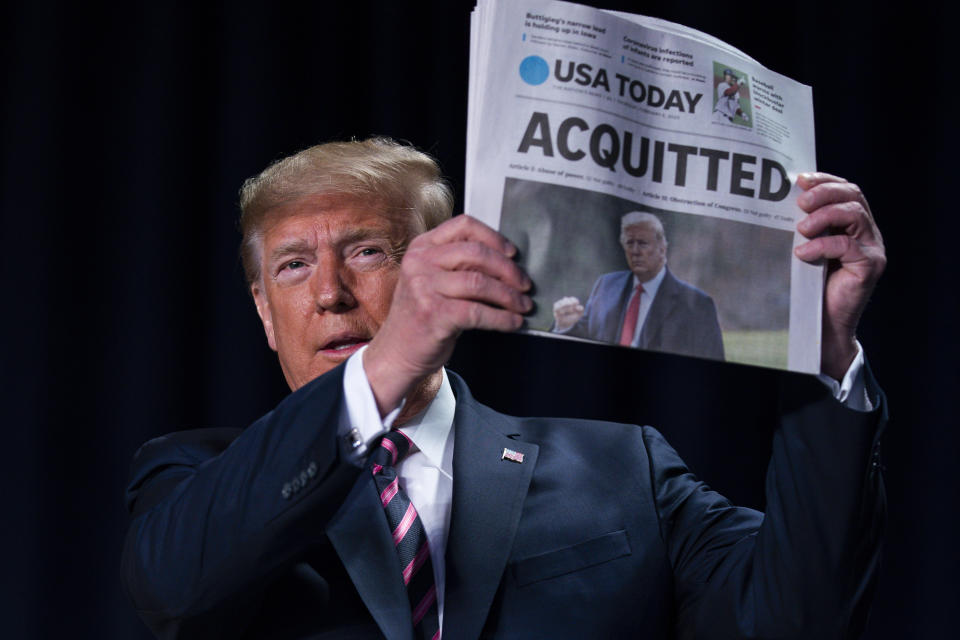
left=122, top=367, right=883, bottom=640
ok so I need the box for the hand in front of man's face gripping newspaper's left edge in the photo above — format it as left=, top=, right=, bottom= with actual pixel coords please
left=363, top=215, right=533, bottom=415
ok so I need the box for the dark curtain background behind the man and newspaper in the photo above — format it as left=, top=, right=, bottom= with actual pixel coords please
left=0, top=0, right=960, bottom=639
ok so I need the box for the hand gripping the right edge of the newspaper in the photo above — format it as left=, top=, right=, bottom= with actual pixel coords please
left=794, top=173, right=887, bottom=380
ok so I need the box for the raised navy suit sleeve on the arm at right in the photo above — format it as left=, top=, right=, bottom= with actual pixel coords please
left=645, top=370, right=886, bottom=639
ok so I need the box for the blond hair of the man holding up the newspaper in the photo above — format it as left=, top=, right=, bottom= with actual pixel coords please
left=240, top=137, right=453, bottom=284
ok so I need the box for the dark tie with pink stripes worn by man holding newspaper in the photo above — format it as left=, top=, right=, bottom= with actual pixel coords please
left=370, top=431, right=440, bottom=640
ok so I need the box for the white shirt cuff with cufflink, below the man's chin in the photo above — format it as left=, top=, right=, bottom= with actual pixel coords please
left=338, top=346, right=404, bottom=459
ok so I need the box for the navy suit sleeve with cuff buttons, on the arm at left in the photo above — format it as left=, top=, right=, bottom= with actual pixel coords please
left=122, top=367, right=361, bottom=638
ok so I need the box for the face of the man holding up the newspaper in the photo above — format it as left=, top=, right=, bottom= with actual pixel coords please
left=251, top=196, right=409, bottom=390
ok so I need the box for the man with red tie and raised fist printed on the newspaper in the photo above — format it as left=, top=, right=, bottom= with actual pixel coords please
left=552, top=211, right=723, bottom=360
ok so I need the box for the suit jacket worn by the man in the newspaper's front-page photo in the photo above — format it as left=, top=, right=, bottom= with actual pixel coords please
left=562, top=269, right=723, bottom=360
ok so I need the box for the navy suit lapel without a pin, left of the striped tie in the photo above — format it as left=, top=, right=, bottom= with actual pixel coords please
left=327, top=472, right=413, bottom=640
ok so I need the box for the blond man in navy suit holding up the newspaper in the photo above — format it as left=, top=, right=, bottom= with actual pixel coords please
left=123, top=140, right=884, bottom=639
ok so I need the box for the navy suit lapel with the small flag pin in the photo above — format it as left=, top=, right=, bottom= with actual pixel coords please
left=443, top=374, right=539, bottom=640
